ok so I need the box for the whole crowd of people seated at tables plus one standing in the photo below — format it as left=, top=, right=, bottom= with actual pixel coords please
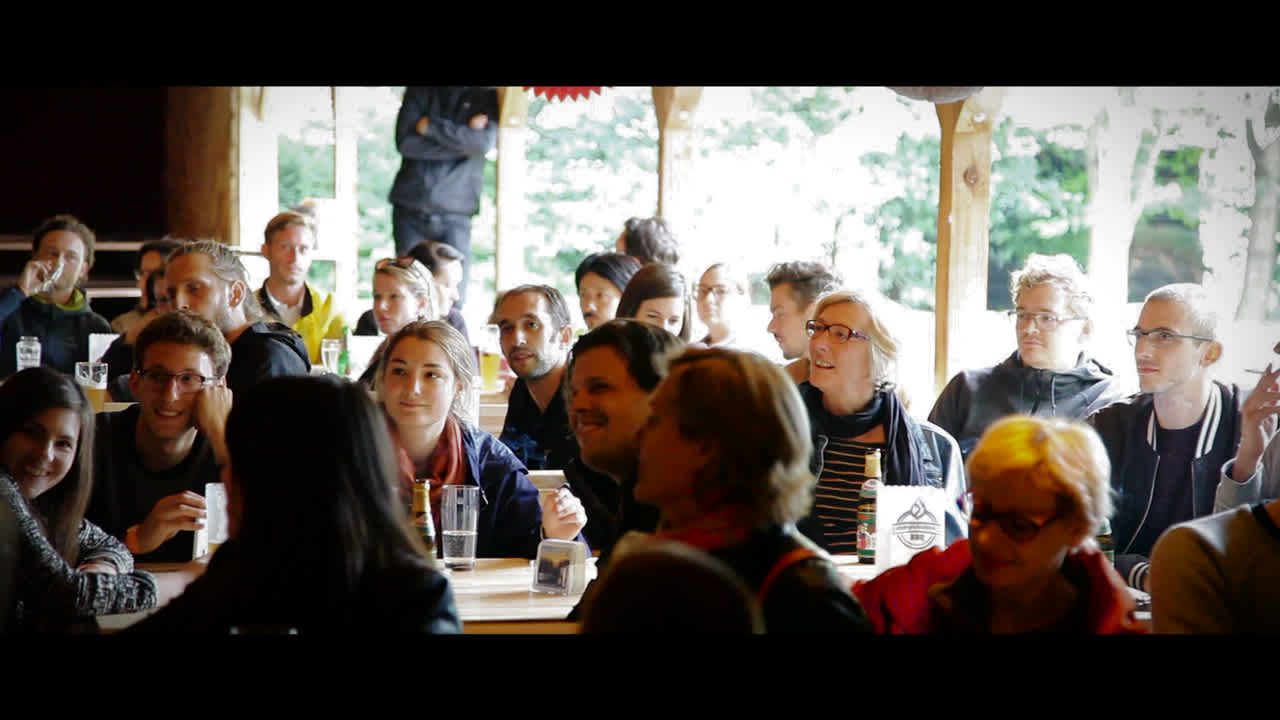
left=0, top=88, right=1280, bottom=634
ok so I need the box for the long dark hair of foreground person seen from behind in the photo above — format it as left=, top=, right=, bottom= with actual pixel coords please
left=227, top=375, right=431, bottom=591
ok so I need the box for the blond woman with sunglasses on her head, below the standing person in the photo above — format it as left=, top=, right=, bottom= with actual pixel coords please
left=357, top=258, right=440, bottom=387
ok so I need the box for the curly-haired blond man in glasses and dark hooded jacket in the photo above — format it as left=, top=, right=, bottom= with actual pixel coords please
left=929, top=254, right=1124, bottom=459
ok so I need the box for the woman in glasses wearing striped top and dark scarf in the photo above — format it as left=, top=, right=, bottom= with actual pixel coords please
left=799, top=290, right=963, bottom=553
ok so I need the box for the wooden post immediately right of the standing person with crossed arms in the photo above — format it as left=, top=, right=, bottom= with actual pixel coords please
left=491, top=86, right=530, bottom=292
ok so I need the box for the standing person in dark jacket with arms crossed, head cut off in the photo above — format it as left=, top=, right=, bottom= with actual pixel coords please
left=388, top=86, right=499, bottom=302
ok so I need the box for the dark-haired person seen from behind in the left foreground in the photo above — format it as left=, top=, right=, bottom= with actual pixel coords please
left=125, top=375, right=462, bottom=634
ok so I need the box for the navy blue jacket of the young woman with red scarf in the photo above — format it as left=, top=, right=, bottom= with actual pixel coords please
left=462, top=423, right=586, bottom=559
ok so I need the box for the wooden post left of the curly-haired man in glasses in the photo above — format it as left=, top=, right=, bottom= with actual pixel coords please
left=933, top=87, right=1005, bottom=393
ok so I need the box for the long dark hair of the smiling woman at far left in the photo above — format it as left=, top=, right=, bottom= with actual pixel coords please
left=0, top=366, right=93, bottom=566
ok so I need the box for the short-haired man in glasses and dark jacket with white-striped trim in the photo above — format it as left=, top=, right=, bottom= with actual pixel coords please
left=1089, top=283, right=1243, bottom=591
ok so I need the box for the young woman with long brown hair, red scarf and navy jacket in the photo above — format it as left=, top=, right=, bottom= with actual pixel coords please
left=374, top=320, right=586, bottom=559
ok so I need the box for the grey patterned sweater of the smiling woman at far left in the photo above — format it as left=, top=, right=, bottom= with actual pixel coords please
left=0, top=471, right=156, bottom=633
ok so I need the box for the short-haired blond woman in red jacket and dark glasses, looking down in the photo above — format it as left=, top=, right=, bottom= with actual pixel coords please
left=854, top=415, right=1146, bottom=634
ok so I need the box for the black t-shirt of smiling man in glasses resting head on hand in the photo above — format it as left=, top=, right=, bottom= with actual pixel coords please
left=84, top=405, right=219, bottom=562
